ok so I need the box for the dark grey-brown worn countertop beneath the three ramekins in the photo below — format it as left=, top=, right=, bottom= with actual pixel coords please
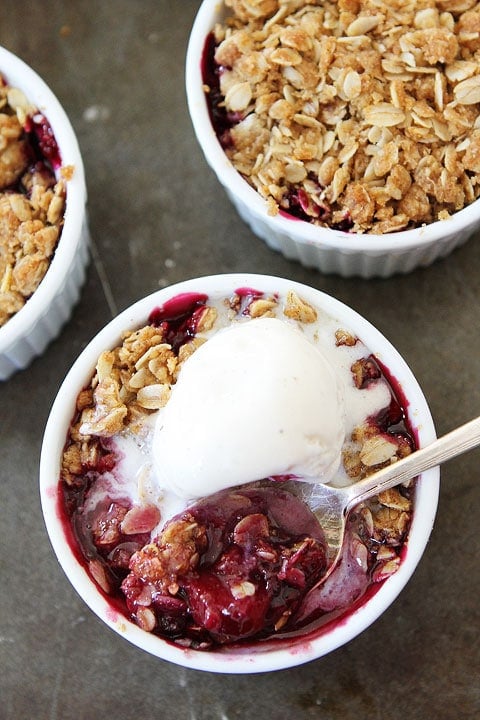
left=0, top=0, right=480, bottom=720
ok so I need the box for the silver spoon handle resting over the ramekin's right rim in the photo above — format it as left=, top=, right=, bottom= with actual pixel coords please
left=345, top=417, right=480, bottom=510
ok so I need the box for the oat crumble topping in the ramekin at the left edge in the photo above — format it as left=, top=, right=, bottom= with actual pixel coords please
left=0, top=75, right=67, bottom=327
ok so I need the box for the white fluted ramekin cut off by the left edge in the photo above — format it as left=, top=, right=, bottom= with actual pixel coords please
left=0, top=48, right=88, bottom=380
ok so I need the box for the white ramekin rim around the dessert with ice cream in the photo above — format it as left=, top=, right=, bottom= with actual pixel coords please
left=40, top=275, right=439, bottom=673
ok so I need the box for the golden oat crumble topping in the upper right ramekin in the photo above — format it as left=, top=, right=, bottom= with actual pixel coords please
left=212, top=0, right=480, bottom=234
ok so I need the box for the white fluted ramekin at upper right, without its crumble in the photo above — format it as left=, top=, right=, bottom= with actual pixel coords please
left=186, top=0, right=480, bottom=278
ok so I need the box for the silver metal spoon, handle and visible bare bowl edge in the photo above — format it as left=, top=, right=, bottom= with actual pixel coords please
left=299, top=417, right=480, bottom=587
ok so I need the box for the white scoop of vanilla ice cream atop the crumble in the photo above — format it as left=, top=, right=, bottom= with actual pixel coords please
left=153, top=318, right=345, bottom=498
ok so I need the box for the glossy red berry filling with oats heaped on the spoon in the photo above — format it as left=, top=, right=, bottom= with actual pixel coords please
left=122, top=487, right=326, bottom=646
